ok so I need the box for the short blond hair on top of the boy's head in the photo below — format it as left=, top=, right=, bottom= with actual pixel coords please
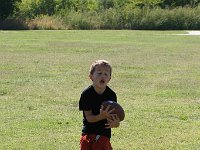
left=90, top=60, right=112, bottom=75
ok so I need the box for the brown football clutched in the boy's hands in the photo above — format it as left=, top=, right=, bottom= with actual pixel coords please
left=102, top=101, right=125, bottom=121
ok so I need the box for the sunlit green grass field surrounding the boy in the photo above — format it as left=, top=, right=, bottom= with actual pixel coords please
left=0, top=30, right=200, bottom=150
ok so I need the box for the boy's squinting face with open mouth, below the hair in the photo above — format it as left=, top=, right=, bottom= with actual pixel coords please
left=90, top=66, right=111, bottom=90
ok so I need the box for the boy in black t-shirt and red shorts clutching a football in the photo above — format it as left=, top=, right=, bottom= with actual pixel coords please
left=79, top=60, right=120, bottom=150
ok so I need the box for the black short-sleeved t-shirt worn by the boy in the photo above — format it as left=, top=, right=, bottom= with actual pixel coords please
left=79, top=86, right=117, bottom=138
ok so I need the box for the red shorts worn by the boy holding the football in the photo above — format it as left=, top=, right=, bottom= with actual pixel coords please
left=80, top=134, right=112, bottom=150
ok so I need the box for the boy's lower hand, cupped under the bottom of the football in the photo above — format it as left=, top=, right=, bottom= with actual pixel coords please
left=106, top=114, right=120, bottom=129
